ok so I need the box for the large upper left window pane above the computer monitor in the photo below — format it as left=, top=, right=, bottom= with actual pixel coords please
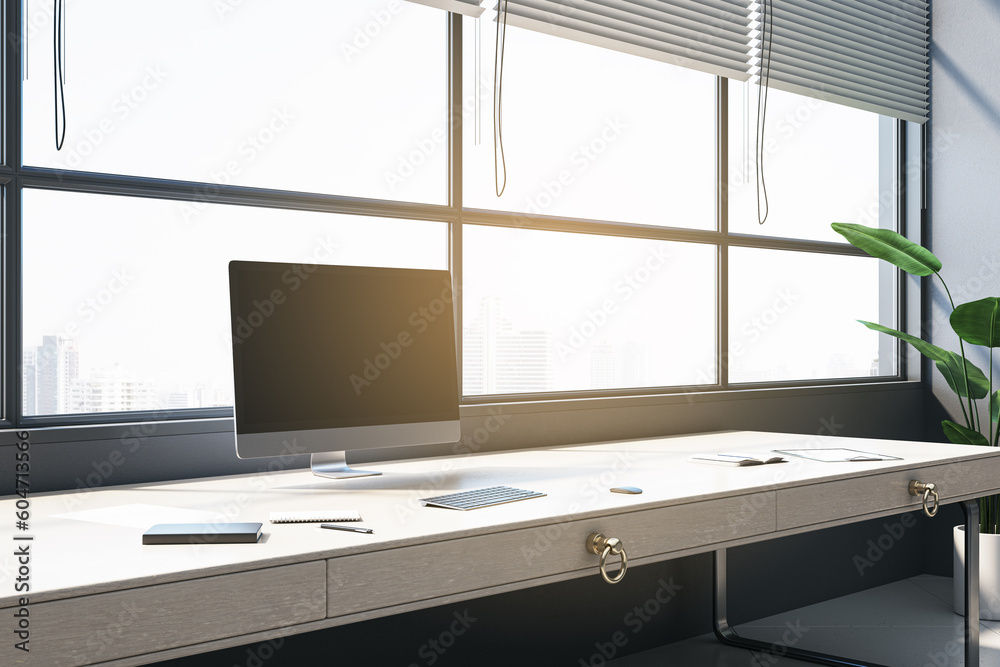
left=24, top=0, right=447, bottom=204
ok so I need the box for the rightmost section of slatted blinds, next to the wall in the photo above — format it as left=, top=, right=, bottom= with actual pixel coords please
left=751, top=0, right=929, bottom=123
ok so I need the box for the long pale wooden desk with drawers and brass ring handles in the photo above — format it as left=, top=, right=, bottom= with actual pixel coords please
left=0, top=432, right=1000, bottom=667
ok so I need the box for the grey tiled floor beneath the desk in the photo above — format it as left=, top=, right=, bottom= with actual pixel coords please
left=609, top=575, right=1000, bottom=667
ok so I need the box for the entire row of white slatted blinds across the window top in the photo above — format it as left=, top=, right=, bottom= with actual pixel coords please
left=410, top=0, right=930, bottom=123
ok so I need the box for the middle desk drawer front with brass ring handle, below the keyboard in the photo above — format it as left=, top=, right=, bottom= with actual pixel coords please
left=327, top=492, right=775, bottom=618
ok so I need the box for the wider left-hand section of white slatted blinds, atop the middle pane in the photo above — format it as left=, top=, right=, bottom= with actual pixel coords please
left=490, top=0, right=751, bottom=81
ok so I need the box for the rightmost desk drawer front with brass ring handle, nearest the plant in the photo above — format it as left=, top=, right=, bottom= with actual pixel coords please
left=777, top=457, right=1000, bottom=530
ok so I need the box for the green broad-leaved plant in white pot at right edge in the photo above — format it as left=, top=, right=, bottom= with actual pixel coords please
left=832, top=222, right=1000, bottom=620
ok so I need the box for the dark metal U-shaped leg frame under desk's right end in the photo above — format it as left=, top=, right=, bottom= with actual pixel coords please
left=712, top=500, right=979, bottom=667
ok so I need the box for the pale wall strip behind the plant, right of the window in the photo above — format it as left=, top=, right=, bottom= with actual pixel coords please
left=924, top=0, right=1000, bottom=438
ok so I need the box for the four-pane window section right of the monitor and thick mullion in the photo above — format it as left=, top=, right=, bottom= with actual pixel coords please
left=463, top=11, right=898, bottom=397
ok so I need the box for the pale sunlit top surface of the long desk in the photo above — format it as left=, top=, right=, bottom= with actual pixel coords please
left=0, top=432, right=1000, bottom=607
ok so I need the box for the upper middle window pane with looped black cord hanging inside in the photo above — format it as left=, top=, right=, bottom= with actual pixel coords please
left=463, top=22, right=716, bottom=229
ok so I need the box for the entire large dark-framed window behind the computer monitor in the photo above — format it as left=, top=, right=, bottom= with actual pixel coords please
left=0, top=0, right=900, bottom=425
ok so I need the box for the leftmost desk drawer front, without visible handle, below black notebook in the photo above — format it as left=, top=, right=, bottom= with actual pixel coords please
left=14, top=561, right=326, bottom=667
